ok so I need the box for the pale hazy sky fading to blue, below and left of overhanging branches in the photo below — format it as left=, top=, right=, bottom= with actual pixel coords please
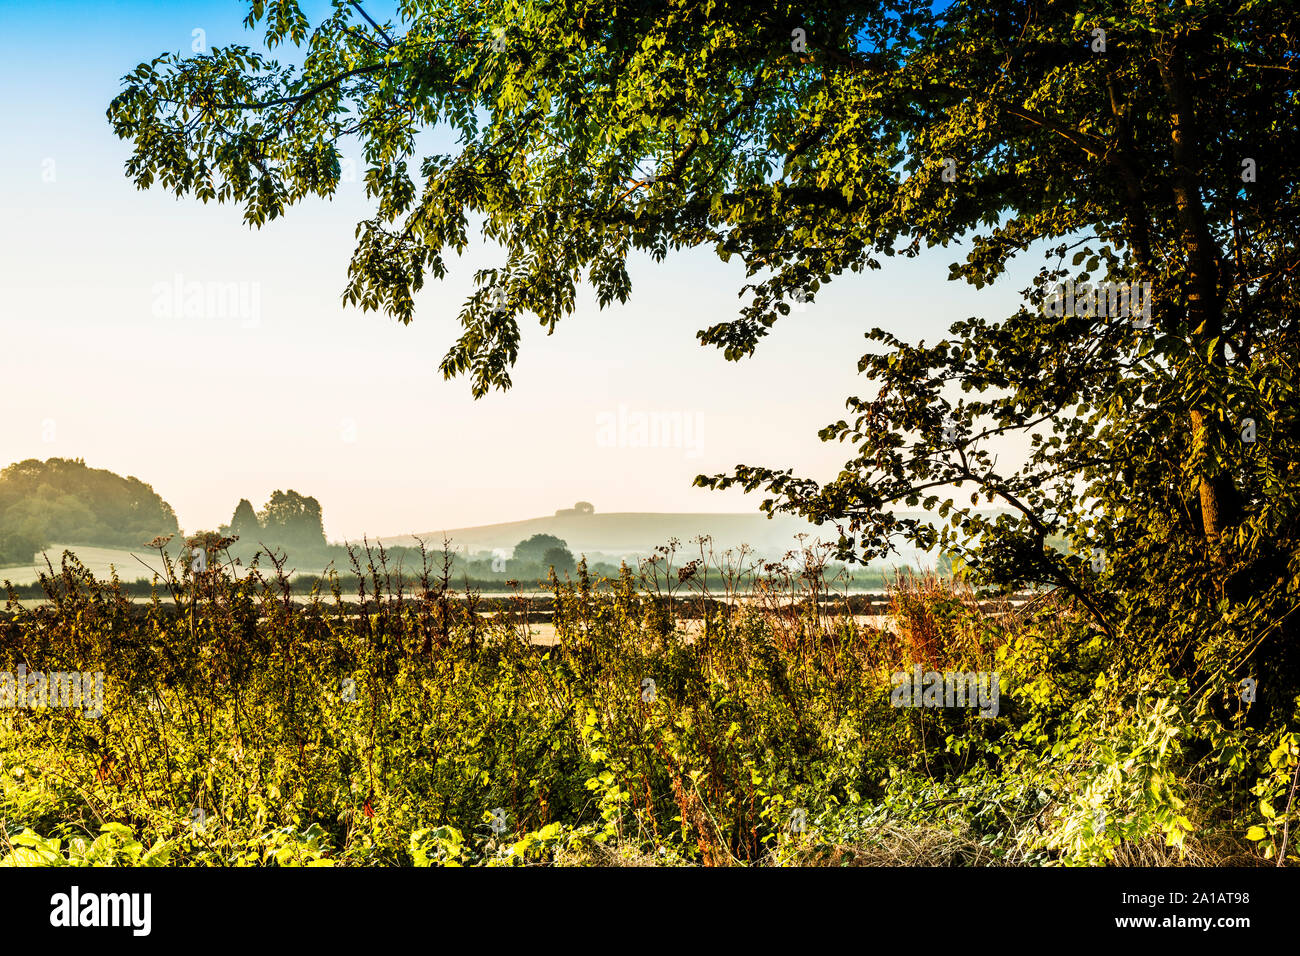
left=0, top=0, right=1023, bottom=540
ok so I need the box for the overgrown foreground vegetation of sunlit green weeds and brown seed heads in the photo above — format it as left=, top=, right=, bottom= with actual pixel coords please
left=0, top=554, right=1279, bottom=866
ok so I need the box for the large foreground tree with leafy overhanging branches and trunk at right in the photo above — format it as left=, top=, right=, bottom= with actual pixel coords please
left=109, top=0, right=1300, bottom=710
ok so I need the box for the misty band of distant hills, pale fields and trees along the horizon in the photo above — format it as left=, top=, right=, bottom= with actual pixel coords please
left=0, top=459, right=941, bottom=597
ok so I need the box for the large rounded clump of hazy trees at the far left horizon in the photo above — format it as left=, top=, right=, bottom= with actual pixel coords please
left=0, top=458, right=178, bottom=564
